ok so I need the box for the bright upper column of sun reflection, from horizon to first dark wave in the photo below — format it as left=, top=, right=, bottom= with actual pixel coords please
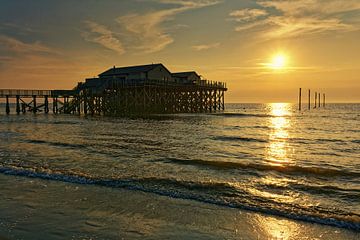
left=266, top=103, right=291, bottom=166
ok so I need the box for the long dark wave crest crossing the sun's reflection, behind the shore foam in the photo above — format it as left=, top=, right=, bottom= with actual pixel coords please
left=158, top=158, right=360, bottom=177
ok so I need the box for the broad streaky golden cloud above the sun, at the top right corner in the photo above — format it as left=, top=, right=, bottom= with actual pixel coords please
left=229, top=0, right=360, bottom=39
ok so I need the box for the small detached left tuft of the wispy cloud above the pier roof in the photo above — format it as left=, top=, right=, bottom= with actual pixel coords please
left=82, top=21, right=125, bottom=54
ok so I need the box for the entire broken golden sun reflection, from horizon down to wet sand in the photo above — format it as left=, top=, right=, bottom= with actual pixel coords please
left=257, top=103, right=299, bottom=239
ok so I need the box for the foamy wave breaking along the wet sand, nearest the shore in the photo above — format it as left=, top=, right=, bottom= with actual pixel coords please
left=0, top=166, right=360, bottom=231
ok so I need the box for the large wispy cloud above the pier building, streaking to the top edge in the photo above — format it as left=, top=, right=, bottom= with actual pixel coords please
left=82, top=0, right=221, bottom=54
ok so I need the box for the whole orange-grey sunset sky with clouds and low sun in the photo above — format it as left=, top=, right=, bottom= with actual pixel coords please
left=0, top=0, right=360, bottom=102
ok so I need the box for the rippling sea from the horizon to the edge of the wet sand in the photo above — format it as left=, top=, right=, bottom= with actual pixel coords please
left=0, top=104, right=360, bottom=238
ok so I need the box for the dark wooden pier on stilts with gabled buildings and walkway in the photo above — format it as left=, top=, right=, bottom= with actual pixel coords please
left=0, top=64, right=227, bottom=116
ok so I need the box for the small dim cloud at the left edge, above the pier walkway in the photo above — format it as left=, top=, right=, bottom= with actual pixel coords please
left=0, top=35, right=58, bottom=54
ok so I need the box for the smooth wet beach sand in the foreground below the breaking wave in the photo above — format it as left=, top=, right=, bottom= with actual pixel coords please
left=0, top=174, right=360, bottom=239
